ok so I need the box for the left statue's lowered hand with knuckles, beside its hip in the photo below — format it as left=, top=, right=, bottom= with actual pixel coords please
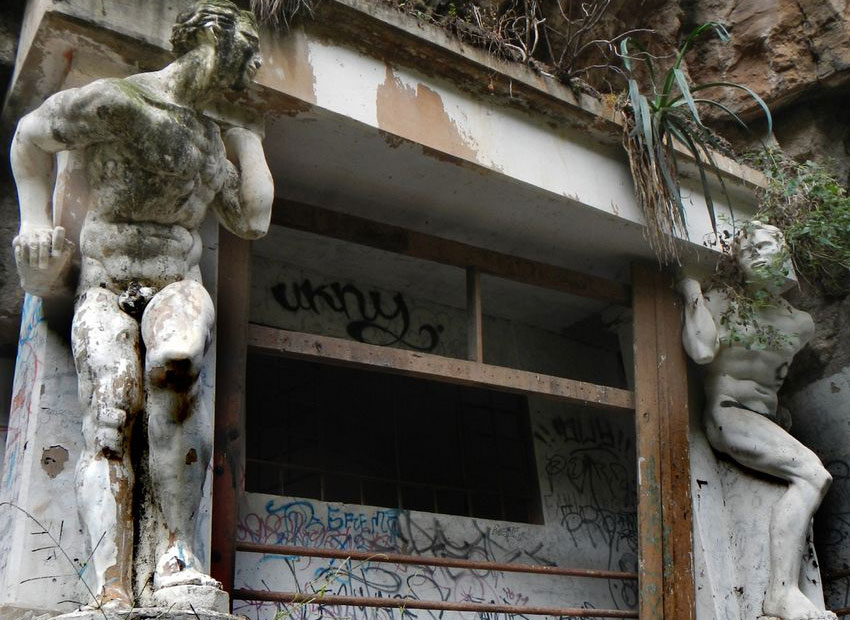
left=12, top=226, right=75, bottom=297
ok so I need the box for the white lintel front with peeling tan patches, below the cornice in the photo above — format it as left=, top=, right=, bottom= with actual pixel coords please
left=250, top=27, right=754, bottom=243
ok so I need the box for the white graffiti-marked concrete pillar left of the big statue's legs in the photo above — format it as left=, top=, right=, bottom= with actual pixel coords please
left=0, top=295, right=88, bottom=620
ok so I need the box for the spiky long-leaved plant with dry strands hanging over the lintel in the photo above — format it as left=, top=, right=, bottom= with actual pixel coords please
left=620, top=22, right=773, bottom=260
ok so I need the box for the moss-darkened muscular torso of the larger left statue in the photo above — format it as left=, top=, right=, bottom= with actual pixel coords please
left=71, top=78, right=232, bottom=293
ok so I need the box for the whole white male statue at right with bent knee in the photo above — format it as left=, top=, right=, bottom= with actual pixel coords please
left=678, top=222, right=835, bottom=620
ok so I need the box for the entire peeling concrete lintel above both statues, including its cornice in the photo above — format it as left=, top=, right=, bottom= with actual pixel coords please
left=4, top=0, right=762, bottom=270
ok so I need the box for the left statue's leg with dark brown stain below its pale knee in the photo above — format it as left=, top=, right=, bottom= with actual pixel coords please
left=142, top=280, right=218, bottom=588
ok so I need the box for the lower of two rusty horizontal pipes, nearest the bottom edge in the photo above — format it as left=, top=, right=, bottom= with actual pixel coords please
left=233, top=590, right=638, bottom=618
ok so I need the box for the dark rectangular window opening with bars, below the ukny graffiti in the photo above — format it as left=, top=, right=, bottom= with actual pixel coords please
left=246, top=354, right=542, bottom=523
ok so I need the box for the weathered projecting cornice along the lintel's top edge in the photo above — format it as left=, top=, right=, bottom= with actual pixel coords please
left=4, top=0, right=766, bottom=188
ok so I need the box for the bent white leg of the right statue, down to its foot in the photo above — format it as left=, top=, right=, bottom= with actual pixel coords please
left=706, top=398, right=835, bottom=620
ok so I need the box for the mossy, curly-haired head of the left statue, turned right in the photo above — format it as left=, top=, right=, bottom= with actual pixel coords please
left=171, top=0, right=261, bottom=90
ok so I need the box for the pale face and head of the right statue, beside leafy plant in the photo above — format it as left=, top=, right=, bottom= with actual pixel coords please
left=733, top=220, right=788, bottom=286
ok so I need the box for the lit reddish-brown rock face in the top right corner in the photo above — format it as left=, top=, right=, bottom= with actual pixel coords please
left=616, top=0, right=850, bottom=180
